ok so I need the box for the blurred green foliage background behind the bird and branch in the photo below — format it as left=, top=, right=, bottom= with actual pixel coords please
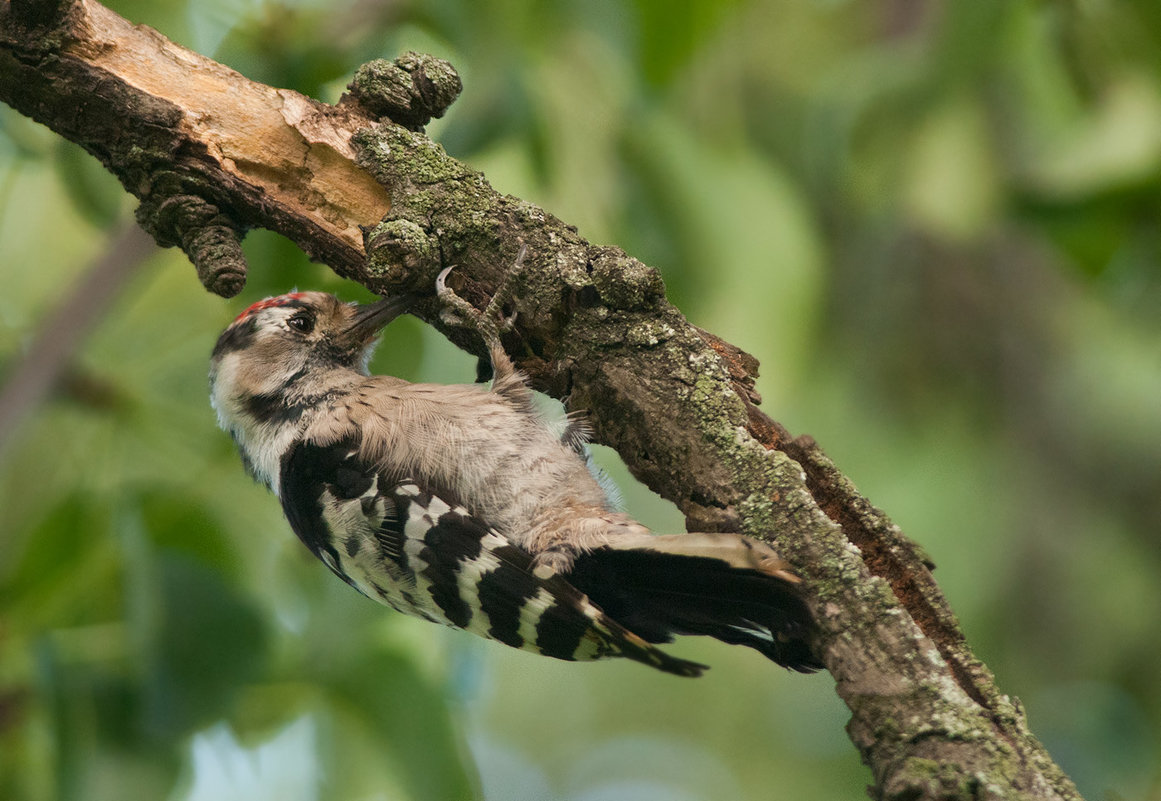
left=0, top=0, right=1161, bottom=801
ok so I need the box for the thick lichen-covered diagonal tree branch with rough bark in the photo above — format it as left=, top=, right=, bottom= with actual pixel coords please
left=0, top=0, right=1079, bottom=799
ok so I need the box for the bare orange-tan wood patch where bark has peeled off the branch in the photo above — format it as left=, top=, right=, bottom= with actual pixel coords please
left=63, top=1, right=391, bottom=251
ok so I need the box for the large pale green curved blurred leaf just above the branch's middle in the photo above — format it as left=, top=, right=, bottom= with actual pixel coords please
left=626, top=117, right=822, bottom=392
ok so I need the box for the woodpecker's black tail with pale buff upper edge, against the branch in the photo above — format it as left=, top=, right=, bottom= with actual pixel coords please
left=568, top=534, right=822, bottom=673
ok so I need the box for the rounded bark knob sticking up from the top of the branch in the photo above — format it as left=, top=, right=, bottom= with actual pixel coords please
left=347, top=51, right=463, bottom=131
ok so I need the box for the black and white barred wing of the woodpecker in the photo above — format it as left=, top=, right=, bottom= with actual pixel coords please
left=280, top=441, right=705, bottom=676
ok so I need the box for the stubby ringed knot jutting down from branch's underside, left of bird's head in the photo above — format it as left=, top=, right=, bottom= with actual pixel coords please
left=137, top=185, right=246, bottom=297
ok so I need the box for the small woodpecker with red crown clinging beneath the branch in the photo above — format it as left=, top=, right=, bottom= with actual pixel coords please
left=210, top=252, right=822, bottom=676
